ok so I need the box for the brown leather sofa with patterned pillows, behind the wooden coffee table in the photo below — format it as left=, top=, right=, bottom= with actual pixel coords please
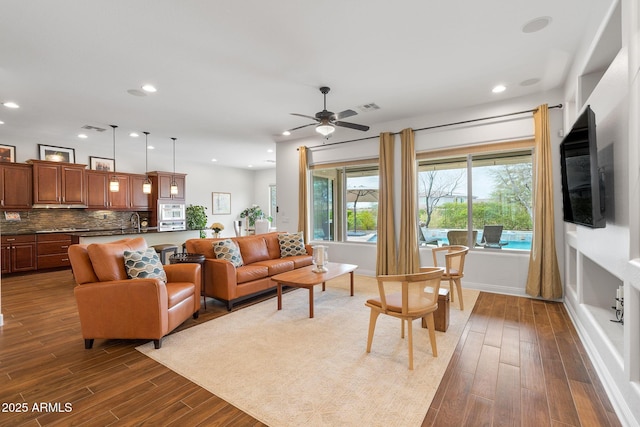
left=185, top=232, right=313, bottom=310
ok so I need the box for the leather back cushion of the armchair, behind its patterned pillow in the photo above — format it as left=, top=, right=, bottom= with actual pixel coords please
left=87, top=237, right=147, bottom=282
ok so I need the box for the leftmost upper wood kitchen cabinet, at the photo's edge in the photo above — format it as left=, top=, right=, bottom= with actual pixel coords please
left=0, top=163, right=33, bottom=210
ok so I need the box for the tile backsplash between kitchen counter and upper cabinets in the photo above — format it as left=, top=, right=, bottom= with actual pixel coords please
left=0, top=209, right=150, bottom=234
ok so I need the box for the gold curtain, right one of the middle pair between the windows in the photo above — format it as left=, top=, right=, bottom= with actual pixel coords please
left=397, top=128, right=420, bottom=274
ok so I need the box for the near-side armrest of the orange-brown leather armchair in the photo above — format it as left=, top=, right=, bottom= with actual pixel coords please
left=74, top=279, right=169, bottom=339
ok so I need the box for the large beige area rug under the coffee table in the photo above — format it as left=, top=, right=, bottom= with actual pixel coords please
left=138, top=275, right=479, bottom=427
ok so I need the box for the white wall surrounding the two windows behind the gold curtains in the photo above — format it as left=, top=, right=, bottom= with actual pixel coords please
left=276, top=91, right=564, bottom=295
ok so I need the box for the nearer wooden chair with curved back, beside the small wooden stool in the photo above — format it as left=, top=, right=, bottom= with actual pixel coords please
left=365, top=267, right=444, bottom=369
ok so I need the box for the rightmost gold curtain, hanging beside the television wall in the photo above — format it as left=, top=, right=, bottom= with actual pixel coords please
left=526, top=104, right=562, bottom=299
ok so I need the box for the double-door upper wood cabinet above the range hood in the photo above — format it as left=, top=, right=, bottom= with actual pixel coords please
left=29, top=160, right=86, bottom=205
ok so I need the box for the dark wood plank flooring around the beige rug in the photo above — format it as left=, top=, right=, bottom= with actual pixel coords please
left=0, top=270, right=620, bottom=427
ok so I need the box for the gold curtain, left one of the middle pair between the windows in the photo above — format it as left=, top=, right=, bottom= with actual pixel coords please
left=376, top=132, right=396, bottom=275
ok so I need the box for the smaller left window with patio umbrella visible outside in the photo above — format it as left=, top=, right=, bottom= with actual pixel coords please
left=311, top=164, right=379, bottom=243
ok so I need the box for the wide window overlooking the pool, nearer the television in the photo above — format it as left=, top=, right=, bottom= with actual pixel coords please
left=418, top=148, right=533, bottom=250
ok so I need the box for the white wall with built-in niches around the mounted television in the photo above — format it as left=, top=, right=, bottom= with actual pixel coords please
left=564, top=0, right=640, bottom=425
